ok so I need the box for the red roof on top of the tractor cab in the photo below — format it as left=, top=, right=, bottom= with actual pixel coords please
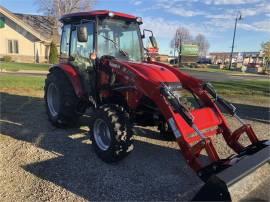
left=60, top=10, right=137, bottom=22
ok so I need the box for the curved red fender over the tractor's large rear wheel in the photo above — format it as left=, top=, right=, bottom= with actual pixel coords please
left=49, top=64, right=85, bottom=98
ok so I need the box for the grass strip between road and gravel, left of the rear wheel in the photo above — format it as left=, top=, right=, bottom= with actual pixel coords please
left=0, top=76, right=45, bottom=90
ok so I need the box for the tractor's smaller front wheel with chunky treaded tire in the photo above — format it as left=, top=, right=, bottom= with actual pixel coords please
left=90, top=105, right=133, bottom=163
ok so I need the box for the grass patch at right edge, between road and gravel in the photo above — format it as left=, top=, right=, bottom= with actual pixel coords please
left=212, top=79, right=270, bottom=99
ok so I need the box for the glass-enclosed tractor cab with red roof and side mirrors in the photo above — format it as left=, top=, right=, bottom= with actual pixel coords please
left=61, top=11, right=156, bottom=64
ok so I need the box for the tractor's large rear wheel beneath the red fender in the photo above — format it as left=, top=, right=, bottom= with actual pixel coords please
left=44, top=69, right=82, bottom=127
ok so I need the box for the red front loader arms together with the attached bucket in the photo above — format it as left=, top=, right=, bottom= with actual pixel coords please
left=147, top=62, right=270, bottom=201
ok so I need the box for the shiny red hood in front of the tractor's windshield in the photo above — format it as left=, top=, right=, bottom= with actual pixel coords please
left=124, top=61, right=180, bottom=82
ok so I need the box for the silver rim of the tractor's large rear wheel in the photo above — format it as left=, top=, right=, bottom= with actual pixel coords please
left=47, top=83, right=59, bottom=117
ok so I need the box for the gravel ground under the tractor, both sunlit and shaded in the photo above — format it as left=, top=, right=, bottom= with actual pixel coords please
left=0, top=92, right=269, bottom=201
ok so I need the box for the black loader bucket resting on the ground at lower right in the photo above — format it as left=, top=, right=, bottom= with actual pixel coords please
left=192, top=141, right=270, bottom=201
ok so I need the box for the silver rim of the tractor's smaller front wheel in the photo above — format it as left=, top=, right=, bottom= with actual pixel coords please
left=93, top=119, right=111, bottom=151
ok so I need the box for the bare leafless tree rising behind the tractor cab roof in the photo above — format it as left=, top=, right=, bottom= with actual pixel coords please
left=36, top=0, right=96, bottom=31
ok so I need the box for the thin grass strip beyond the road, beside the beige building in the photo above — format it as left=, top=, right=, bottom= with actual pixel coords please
left=0, top=62, right=50, bottom=71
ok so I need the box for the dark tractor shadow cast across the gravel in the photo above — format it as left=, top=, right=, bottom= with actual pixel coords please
left=0, top=93, right=201, bottom=201
